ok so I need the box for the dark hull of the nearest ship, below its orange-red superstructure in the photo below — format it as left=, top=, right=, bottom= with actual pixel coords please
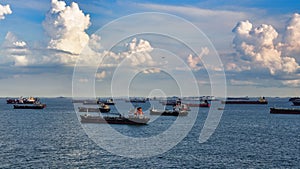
left=80, top=114, right=150, bottom=125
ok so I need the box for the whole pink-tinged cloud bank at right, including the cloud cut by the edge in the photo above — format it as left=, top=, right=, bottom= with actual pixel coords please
left=233, top=14, right=300, bottom=75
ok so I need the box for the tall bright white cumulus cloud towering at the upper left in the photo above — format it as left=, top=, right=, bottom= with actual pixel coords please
left=43, top=0, right=91, bottom=54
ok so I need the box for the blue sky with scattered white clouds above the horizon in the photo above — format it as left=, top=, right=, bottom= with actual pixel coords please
left=0, top=0, right=300, bottom=97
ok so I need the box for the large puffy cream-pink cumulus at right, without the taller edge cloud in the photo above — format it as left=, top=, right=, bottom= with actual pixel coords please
left=233, top=14, right=299, bottom=75
